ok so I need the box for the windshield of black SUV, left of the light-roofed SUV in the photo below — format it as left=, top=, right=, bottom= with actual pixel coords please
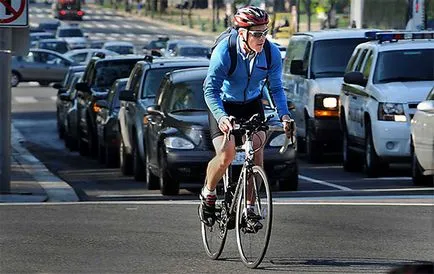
left=92, top=59, right=137, bottom=88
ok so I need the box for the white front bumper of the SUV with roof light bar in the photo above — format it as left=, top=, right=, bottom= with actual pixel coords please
left=372, top=121, right=411, bottom=159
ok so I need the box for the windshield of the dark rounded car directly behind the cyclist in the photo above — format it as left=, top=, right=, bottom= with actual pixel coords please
left=167, top=80, right=207, bottom=112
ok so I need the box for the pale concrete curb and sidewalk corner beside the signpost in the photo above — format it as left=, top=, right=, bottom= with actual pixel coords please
left=11, top=123, right=80, bottom=202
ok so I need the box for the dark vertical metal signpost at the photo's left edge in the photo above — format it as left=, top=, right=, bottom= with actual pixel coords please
left=0, top=27, right=12, bottom=193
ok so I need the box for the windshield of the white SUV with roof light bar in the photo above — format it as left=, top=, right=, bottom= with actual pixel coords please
left=373, top=49, right=434, bottom=84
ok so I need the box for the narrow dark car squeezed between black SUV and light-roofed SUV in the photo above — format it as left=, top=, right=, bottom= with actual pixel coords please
left=96, top=78, right=128, bottom=167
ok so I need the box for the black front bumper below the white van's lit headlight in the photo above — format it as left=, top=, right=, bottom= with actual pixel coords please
left=308, top=118, right=342, bottom=143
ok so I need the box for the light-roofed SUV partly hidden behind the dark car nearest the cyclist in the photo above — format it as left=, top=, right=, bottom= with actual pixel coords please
left=118, top=56, right=209, bottom=182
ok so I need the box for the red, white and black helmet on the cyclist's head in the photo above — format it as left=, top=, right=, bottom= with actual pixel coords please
left=234, top=6, right=269, bottom=28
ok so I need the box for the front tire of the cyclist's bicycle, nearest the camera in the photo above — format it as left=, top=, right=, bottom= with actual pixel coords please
left=236, top=166, right=273, bottom=268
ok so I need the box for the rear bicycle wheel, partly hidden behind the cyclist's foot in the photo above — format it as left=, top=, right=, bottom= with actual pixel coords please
left=199, top=195, right=228, bottom=260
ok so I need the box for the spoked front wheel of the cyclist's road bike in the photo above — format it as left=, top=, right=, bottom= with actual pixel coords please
left=236, top=166, right=273, bottom=268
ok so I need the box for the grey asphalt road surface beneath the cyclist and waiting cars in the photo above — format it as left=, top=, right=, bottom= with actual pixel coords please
left=0, top=3, right=434, bottom=273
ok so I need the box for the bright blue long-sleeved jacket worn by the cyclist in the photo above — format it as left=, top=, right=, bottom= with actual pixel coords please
left=204, top=37, right=289, bottom=121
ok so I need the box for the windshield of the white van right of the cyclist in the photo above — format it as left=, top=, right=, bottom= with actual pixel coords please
left=311, top=38, right=367, bottom=78
